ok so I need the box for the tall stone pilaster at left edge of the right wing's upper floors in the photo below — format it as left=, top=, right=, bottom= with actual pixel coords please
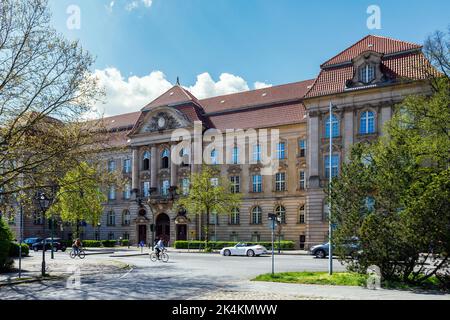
left=308, top=114, right=319, bottom=188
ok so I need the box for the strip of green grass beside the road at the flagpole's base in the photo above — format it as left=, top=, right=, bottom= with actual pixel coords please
left=252, top=272, right=367, bottom=286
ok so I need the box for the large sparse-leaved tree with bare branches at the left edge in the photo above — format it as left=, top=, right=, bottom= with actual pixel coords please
left=0, top=0, right=107, bottom=212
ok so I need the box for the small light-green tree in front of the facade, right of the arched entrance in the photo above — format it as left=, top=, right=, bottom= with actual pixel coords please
left=175, top=166, right=241, bottom=249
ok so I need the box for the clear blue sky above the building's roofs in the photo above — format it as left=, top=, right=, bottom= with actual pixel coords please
left=50, top=0, right=450, bottom=112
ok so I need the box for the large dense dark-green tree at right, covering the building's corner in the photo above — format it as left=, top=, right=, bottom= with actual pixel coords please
left=331, top=29, right=450, bottom=285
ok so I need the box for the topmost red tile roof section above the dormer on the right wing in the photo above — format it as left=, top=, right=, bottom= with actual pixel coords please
left=321, top=35, right=422, bottom=67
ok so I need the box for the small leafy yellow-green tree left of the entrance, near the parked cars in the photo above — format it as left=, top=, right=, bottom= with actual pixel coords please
left=47, top=162, right=106, bottom=237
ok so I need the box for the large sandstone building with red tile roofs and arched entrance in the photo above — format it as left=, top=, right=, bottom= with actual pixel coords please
left=8, top=36, right=429, bottom=248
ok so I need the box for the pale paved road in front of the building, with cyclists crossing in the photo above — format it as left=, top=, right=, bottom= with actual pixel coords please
left=0, top=252, right=449, bottom=300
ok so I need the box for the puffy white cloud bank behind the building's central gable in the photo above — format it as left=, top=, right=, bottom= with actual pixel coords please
left=94, top=68, right=270, bottom=116
